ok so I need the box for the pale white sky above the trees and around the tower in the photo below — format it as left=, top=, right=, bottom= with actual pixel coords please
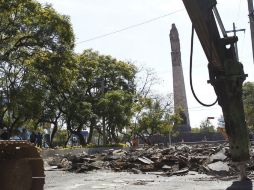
left=39, top=0, right=254, bottom=127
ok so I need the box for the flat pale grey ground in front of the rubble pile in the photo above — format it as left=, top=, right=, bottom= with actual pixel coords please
left=44, top=170, right=253, bottom=190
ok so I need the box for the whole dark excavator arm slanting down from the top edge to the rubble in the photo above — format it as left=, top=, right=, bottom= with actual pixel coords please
left=183, top=0, right=249, bottom=177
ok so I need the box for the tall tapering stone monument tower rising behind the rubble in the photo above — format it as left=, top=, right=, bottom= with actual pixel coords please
left=169, top=24, right=191, bottom=132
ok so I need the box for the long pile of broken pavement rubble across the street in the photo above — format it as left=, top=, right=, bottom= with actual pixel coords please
left=45, top=144, right=253, bottom=176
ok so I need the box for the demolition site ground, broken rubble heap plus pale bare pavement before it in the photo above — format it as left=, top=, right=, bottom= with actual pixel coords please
left=44, top=144, right=254, bottom=190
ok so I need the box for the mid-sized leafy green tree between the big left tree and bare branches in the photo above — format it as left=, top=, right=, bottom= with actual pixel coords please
left=72, top=50, right=136, bottom=143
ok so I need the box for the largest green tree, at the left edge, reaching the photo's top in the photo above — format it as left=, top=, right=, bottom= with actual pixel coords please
left=0, top=0, right=74, bottom=137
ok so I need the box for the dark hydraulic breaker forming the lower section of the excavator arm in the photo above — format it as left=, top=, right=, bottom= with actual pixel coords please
left=209, top=61, right=249, bottom=162
